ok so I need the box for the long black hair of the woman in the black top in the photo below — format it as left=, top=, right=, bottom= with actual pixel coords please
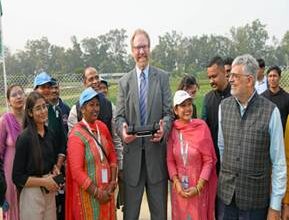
left=23, top=91, right=45, bottom=173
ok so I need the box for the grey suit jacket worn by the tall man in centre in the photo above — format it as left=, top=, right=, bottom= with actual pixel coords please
left=116, top=66, right=172, bottom=186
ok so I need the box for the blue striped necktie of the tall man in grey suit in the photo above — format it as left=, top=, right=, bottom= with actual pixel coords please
left=139, top=72, right=147, bottom=125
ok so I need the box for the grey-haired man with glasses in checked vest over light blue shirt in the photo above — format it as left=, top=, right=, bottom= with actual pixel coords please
left=218, top=54, right=286, bottom=220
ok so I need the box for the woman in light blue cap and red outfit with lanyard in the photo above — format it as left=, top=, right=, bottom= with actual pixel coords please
left=65, top=88, right=117, bottom=220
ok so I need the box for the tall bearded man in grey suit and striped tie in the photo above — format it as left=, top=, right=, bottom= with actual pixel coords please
left=116, top=29, right=172, bottom=220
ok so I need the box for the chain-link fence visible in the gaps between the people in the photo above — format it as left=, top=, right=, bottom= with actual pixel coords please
left=0, top=67, right=289, bottom=115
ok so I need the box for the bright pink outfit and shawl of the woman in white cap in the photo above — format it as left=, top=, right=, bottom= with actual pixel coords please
left=167, top=119, right=217, bottom=220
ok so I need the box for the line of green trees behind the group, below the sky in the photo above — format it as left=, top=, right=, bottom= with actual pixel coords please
left=5, top=19, right=289, bottom=76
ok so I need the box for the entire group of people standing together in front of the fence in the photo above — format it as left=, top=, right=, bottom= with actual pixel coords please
left=0, top=29, right=289, bottom=220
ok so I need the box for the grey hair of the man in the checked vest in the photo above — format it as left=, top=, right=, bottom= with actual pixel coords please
left=232, top=54, right=259, bottom=80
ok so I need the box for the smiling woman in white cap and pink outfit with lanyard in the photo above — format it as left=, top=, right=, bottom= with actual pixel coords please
left=167, top=90, right=217, bottom=220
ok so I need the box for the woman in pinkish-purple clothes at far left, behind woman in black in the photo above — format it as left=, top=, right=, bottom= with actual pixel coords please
left=0, top=85, right=25, bottom=220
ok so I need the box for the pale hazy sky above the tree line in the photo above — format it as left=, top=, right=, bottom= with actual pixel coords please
left=2, top=0, right=289, bottom=51
